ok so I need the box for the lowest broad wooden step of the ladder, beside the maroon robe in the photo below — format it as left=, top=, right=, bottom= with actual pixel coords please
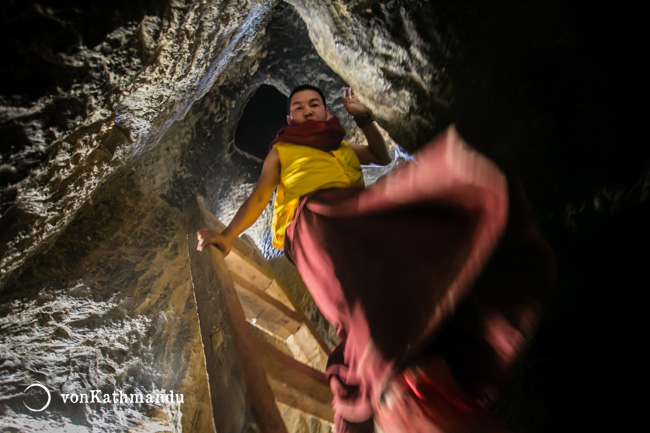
left=255, top=337, right=334, bottom=422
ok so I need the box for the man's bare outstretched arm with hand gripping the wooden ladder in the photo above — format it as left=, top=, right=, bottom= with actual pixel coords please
left=196, top=148, right=280, bottom=255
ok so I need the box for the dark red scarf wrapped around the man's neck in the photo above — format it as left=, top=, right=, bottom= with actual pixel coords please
left=269, top=116, right=345, bottom=152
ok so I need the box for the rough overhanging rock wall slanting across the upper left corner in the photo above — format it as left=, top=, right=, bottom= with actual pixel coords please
left=0, top=0, right=273, bottom=287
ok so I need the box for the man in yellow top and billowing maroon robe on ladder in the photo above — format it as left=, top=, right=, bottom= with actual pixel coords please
left=197, top=85, right=554, bottom=433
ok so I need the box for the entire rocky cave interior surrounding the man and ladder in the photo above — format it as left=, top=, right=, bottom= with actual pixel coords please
left=0, top=0, right=650, bottom=432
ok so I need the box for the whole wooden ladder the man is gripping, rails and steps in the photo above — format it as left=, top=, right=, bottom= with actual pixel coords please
left=185, top=195, right=334, bottom=433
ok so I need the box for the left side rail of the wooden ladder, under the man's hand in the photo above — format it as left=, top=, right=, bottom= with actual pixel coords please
left=185, top=197, right=287, bottom=433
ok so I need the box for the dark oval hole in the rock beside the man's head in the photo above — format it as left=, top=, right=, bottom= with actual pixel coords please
left=235, top=84, right=287, bottom=159
